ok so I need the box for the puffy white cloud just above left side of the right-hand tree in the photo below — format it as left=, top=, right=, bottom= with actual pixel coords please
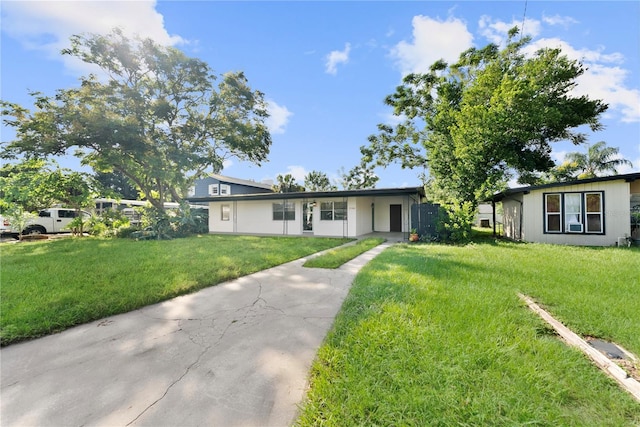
left=391, top=15, right=473, bottom=76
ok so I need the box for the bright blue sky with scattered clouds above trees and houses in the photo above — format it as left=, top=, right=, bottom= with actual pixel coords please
left=0, top=0, right=640, bottom=188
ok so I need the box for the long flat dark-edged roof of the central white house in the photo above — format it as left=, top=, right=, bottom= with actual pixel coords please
left=187, top=187, right=424, bottom=202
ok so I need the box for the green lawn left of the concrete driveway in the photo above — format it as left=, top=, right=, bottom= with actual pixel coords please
left=0, top=235, right=350, bottom=345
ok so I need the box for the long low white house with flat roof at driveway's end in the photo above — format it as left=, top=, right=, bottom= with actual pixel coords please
left=189, top=187, right=424, bottom=237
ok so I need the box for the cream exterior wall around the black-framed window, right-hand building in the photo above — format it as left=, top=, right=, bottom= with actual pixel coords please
left=524, top=180, right=631, bottom=246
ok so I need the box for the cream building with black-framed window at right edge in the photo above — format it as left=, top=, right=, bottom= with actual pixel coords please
left=490, top=173, right=640, bottom=246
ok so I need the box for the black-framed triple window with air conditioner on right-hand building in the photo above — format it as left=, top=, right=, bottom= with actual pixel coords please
left=544, top=191, right=604, bottom=234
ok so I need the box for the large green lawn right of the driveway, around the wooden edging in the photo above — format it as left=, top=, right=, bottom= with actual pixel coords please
left=297, top=242, right=640, bottom=426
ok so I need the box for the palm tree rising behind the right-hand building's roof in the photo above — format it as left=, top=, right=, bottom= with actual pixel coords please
left=565, top=141, right=633, bottom=179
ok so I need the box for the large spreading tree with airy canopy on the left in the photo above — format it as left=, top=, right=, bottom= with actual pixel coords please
left=3, top=30, right=271, bottom=209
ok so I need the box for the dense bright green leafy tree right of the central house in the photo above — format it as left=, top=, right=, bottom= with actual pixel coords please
left=362, top=29, right=607, bottom=206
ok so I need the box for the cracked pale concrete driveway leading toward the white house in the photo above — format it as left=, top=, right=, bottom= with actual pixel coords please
left=0, top=243, right=390, bottom=427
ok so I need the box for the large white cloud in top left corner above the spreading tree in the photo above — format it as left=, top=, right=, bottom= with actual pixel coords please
left=2, top=0, right=186, bottom=74
